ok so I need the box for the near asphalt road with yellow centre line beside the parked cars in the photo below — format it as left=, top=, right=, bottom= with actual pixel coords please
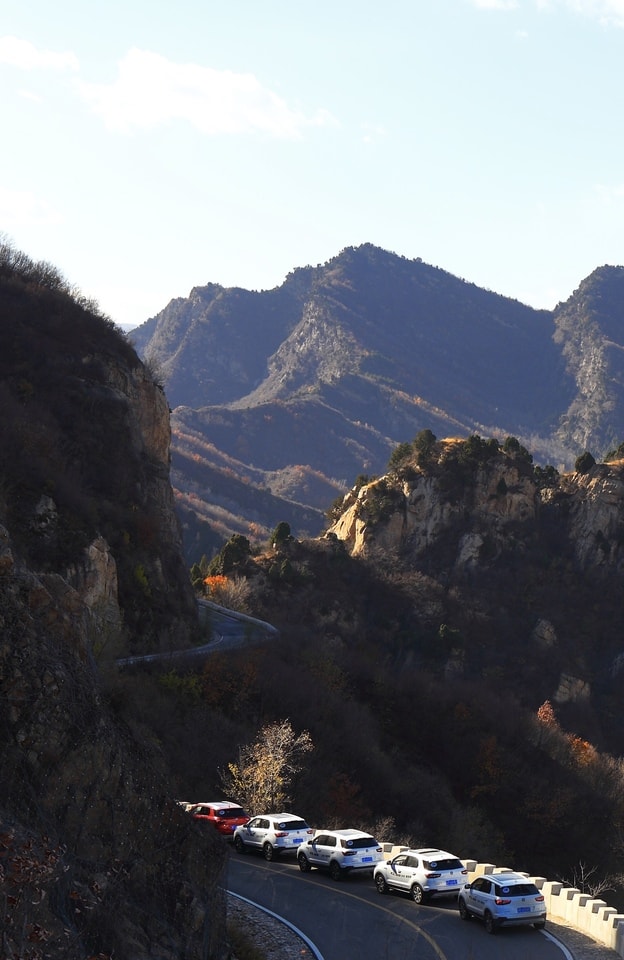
left=227, top=851, right=573, bottom=960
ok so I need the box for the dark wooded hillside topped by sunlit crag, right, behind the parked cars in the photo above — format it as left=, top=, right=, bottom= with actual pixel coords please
left=162, top=433, right=624, bottom=902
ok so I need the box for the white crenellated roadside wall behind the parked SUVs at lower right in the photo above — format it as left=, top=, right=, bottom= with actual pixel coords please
left=382, top=843, right=624, bottom=957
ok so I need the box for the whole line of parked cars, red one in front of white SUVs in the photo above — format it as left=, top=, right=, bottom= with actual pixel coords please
left=179, top=800, right=546, bottom=933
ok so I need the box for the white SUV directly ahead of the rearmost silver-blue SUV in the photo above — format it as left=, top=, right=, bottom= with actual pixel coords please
left=373, top=848, right=468, bottom=903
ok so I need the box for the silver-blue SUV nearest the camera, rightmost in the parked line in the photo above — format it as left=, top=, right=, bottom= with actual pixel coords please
left=457, top=871, right=546, bottom=933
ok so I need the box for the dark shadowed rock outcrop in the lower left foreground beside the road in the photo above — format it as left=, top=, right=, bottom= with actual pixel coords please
left=0, top=528, right=225, bottom=960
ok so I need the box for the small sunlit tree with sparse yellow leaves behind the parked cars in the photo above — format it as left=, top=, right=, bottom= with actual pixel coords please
left=219, top=720, right=314, bottom=816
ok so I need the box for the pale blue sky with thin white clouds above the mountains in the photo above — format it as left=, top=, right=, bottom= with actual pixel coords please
left=0, top=0, right=624, bottom=327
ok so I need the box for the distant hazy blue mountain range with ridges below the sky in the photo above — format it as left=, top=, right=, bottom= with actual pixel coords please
left=131, top=244, right=624, bottom=560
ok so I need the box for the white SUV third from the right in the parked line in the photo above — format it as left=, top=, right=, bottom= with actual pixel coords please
left=297, top=830, right=383, bottom=880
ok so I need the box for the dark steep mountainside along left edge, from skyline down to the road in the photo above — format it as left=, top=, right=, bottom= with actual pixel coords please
left=0, top=244, right=226, bottom=960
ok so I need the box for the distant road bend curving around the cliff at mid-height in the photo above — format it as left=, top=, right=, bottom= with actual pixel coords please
left=115, top=600, right=279, bottom=668
